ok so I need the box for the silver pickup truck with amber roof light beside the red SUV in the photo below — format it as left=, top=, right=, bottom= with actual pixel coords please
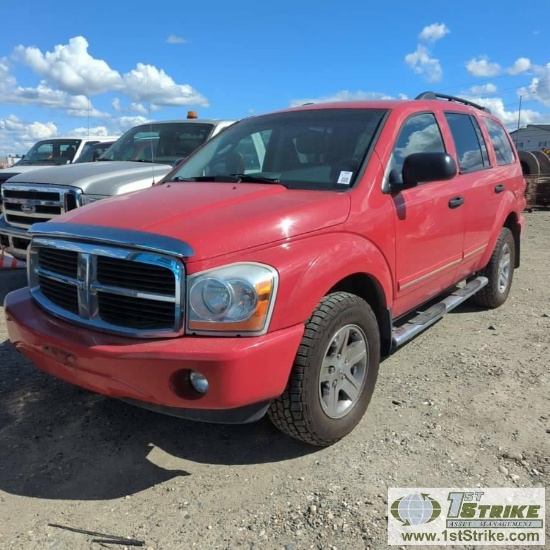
left=0, top=118, right=235, bottom=260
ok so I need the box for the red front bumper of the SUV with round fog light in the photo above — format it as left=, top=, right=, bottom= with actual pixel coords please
left=5, top=288, right=304, bottom=422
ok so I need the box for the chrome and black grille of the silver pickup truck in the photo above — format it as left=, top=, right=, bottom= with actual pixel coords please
left=2, top=183, right=80, bottom=229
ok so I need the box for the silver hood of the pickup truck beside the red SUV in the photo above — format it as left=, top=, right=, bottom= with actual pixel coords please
left=4, top=161, right=172, bottom=195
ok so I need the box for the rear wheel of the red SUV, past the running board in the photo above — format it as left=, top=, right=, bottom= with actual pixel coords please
left=472, top=227, right=516, bottom=309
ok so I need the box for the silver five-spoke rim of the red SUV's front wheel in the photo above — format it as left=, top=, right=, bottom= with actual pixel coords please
left=319, top=325, right=369, bottom=419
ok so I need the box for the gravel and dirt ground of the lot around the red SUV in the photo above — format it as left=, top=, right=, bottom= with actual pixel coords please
left=0, top=211, right=550, bottom=550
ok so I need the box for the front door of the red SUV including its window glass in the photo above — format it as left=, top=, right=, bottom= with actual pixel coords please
left=386, top=113, right=465, bottom=317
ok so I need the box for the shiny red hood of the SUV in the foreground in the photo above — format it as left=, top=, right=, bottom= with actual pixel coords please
left=57, top=182, right=350, bottom=261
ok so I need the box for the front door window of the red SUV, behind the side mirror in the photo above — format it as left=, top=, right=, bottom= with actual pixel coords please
left=387, top=113, right=445, bottom=184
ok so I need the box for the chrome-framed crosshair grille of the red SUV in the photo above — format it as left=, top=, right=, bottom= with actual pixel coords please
left=29, top=238, right=185, bottom=338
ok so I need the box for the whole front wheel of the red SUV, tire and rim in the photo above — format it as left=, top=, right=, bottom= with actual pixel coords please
left=268, top=292, right=380, bottom=446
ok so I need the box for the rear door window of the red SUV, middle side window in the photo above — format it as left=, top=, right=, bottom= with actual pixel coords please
left=445, top=113, right=489, bottom=174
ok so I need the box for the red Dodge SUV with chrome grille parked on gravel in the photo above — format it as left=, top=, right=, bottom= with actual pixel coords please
left=5, top=92, right=525, bottom=445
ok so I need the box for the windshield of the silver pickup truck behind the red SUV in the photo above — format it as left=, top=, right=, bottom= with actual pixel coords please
left=99, top=122, right=214, bottom=164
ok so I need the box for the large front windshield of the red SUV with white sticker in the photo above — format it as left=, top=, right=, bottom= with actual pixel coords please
left=166, top=109, right=386, bottom=191
